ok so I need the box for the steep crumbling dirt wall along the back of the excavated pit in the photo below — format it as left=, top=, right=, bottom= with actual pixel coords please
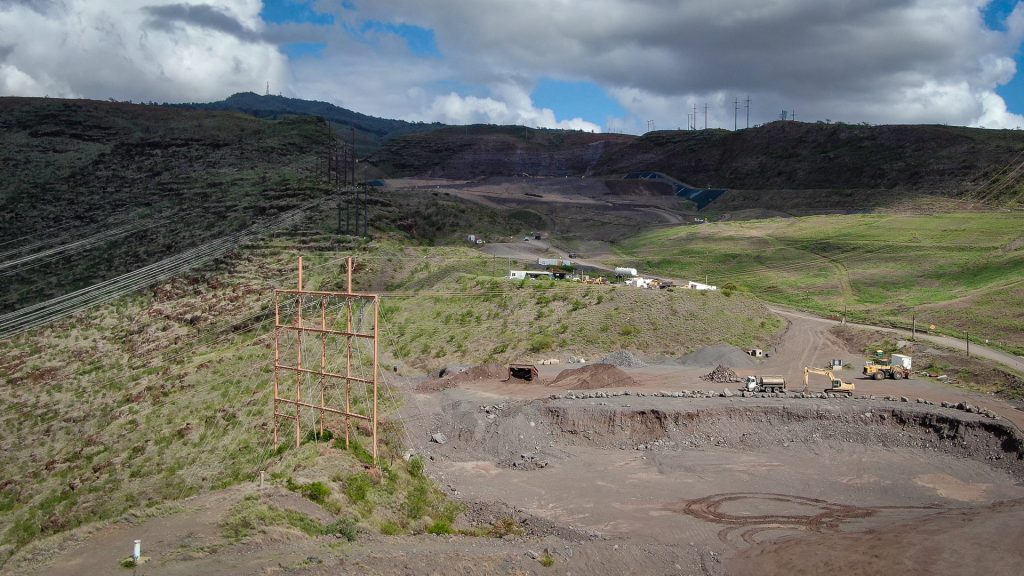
left=423, top=397, right=1024, bottom=481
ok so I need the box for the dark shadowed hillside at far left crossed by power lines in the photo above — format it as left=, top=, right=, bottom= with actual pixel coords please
left=0, top=97, right=329, bottom=314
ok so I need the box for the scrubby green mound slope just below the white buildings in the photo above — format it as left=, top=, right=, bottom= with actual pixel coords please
left=356, top=248, right=781, bottom=369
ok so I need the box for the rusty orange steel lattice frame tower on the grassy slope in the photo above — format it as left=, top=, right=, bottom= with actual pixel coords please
left=273, top=257, right=380, bottom=464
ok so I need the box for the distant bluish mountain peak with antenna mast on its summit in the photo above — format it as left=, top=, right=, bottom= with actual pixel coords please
left=167, top=92, right=444, bottom=156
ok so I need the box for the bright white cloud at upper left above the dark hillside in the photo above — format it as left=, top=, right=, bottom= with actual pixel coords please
left=0, top=0, right=288, bottom=101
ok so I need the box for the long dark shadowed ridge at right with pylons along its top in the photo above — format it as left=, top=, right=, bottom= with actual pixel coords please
left=372, top=122, right=1024, bottom=203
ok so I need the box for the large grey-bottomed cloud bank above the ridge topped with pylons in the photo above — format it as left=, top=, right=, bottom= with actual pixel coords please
left=333, top=0, right=1024, bottom=131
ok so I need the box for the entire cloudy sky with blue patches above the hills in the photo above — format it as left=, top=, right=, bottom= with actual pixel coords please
left=0, top=0, right=1024, bottom=133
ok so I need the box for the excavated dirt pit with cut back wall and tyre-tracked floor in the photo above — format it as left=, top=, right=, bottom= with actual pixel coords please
left=415, top=395, right=1024, bottom=574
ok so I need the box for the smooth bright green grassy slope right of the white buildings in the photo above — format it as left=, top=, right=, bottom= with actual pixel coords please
left=620, top=212, right=1024, bottom=354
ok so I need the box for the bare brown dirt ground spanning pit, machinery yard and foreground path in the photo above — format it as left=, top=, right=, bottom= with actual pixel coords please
left=14, top=307, right=1024, bottom=575
